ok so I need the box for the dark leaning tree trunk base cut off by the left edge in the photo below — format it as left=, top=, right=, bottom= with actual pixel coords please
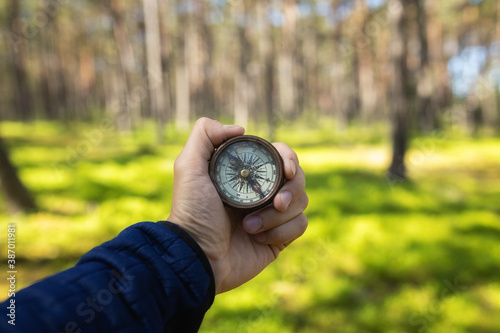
left=0, top=139, right=36, bottom=212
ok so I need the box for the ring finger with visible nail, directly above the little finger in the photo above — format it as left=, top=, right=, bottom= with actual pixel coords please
left=243, top=192, right=309, bottom=234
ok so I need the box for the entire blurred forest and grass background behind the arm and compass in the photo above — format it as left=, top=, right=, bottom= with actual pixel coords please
left=0, top=0, right=500, bottom=333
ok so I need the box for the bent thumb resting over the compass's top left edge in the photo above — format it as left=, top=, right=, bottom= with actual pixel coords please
left=181, top=118, right=245, bottom=164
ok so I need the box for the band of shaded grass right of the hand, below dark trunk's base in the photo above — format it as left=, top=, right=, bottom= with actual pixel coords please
left=306, top=169, right=469, bottom=215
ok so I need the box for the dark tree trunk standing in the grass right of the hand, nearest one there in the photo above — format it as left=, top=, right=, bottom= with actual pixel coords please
left=387, top=0, right=409, bottom=180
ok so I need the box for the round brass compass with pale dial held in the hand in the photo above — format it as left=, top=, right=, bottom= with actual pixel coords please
left=209, top=135, right=285, bottom=211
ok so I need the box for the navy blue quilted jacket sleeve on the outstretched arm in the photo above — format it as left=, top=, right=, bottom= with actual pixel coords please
left=0, top=222, right=215, bottom=333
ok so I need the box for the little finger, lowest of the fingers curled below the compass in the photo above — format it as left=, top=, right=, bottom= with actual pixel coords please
left=253, top=214, right=308, bottom=244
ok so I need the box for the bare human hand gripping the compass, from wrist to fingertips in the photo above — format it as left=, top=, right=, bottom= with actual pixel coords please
left=168, top=118, right=308, bottom=293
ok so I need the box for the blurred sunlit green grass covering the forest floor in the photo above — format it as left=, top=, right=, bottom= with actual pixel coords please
left=0, top=122, right=500, bottom=333
